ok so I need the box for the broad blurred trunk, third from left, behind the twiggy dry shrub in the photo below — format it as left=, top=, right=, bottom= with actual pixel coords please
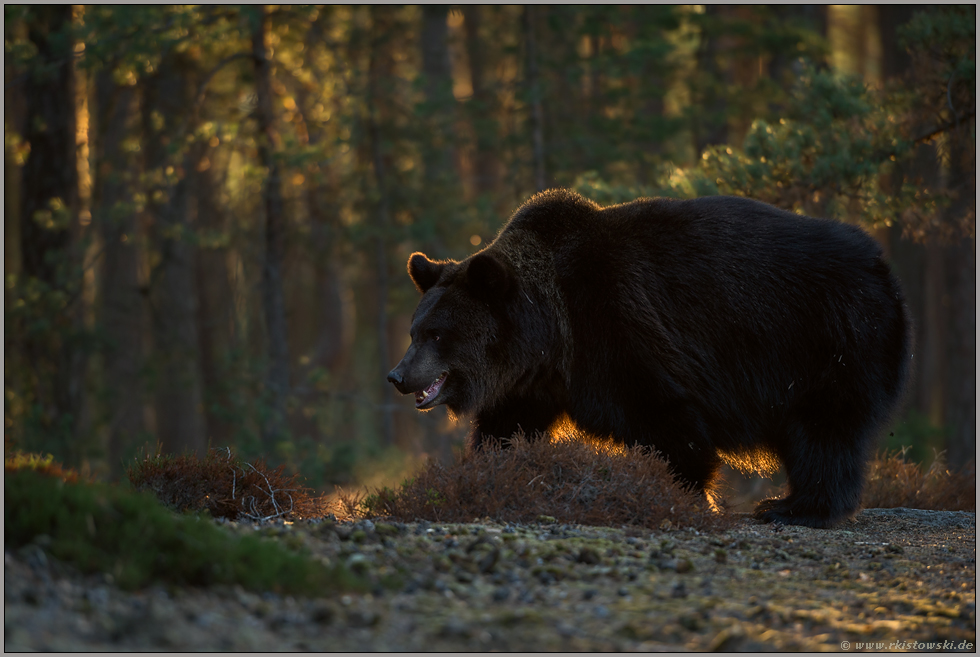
left=142, top=50, right=207, bottom=455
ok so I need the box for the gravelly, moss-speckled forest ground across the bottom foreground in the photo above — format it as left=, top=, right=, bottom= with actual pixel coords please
left=4, top=508, right=976, bottom=652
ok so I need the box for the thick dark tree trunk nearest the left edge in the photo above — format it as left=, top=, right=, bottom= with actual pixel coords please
left=18, top=5, right=81, bottom=463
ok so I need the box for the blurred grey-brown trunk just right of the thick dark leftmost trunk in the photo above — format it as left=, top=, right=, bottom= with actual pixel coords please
left=93, top=69, right=146, bottom=477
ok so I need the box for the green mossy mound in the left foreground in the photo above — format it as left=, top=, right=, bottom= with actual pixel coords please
left=4, top=470, right=362, bottom=595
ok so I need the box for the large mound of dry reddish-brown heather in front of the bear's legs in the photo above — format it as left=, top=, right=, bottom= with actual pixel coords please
left=340, top=433, right=733, bottom=530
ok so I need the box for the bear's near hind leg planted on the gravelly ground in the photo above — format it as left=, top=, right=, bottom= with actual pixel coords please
left=755, top=412, right=874, bottom=528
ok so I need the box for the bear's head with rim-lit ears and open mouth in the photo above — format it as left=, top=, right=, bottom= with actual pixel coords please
left=388, top=251, right=516, bottom=415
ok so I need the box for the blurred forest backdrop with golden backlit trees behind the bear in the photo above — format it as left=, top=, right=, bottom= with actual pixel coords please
left=4, top=5, right=976, bottom=489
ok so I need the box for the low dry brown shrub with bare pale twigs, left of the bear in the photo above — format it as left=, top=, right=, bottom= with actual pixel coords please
left=128, top=448, right=326, bottom=520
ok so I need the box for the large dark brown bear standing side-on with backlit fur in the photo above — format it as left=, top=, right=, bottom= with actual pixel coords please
left=388, top=190, right=911, bottom=527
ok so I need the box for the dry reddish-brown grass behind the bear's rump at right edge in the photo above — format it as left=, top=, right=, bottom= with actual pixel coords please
left=862, top=450, right=977, bottom=511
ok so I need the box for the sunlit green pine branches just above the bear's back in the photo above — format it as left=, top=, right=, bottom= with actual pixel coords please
left=575, top=68, right=937, bottom=232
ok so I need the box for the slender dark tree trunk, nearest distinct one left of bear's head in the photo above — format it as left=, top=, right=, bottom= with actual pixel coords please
left=252, top=5, right=289, bottom=451
